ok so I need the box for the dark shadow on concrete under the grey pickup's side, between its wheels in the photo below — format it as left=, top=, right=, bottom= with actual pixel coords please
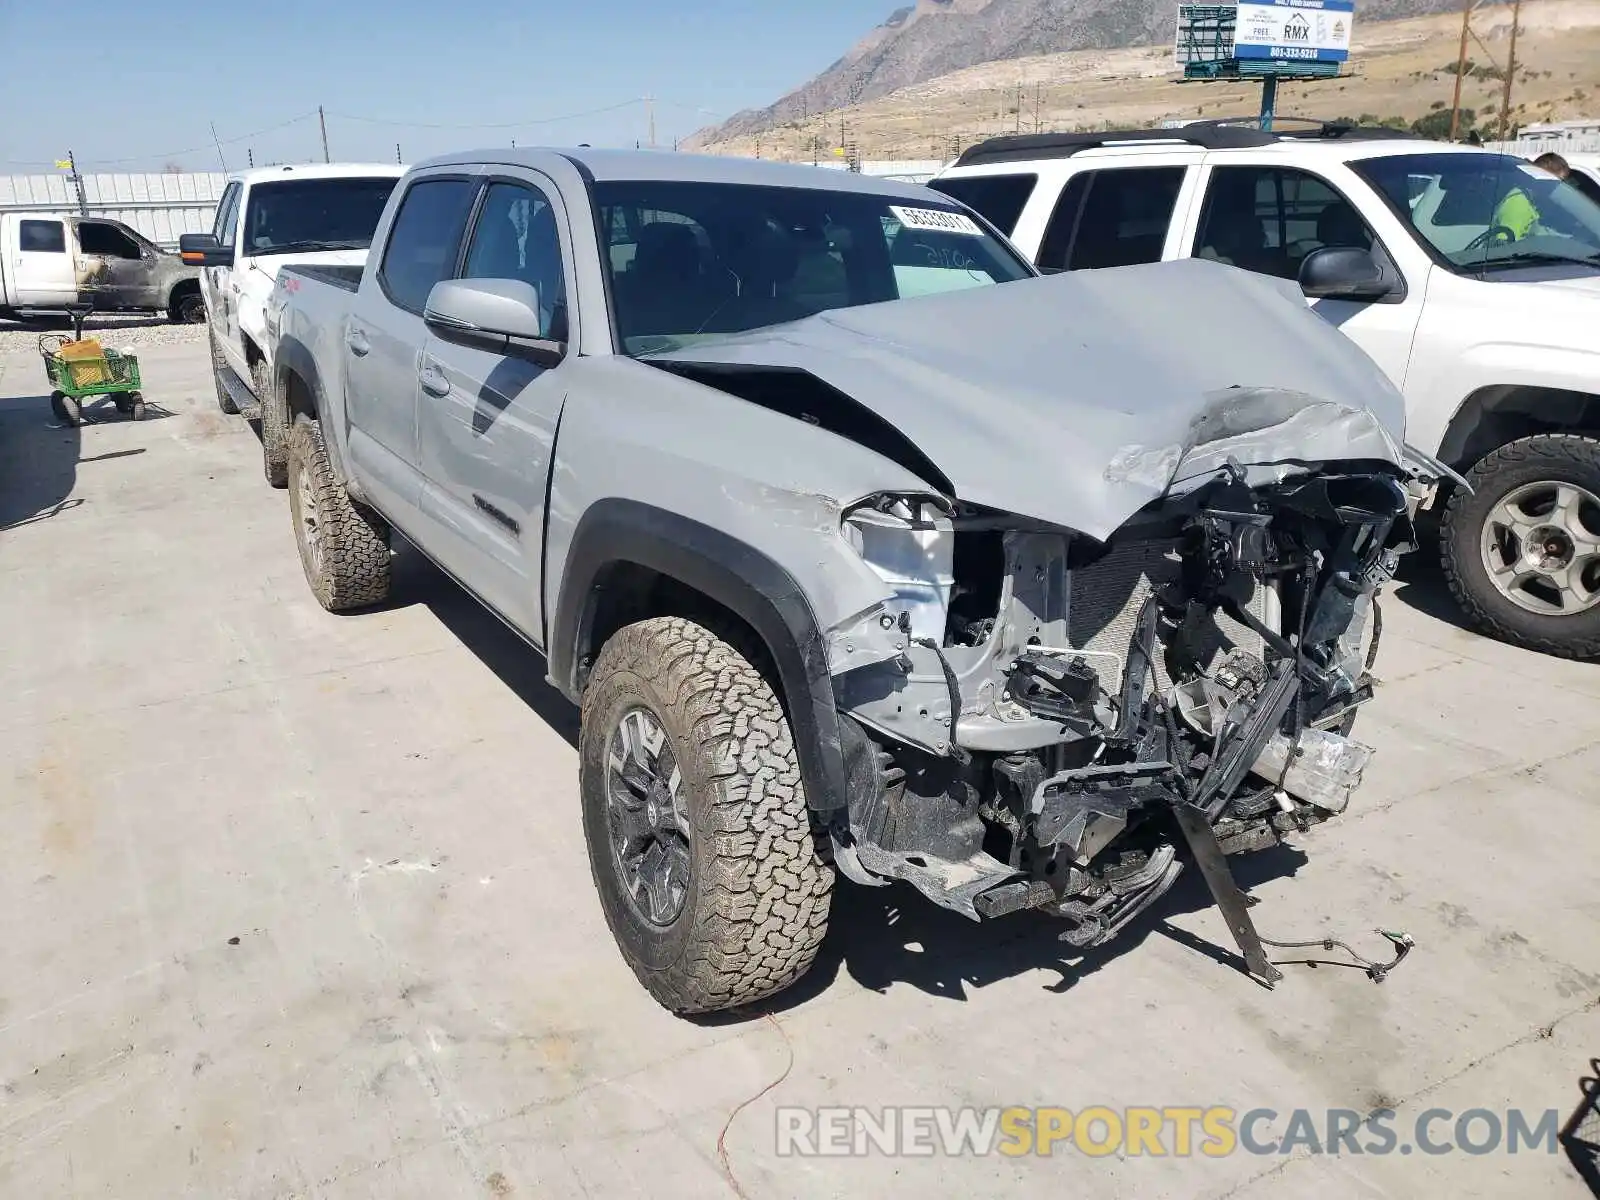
left=394, top=533, right=578, bottom=749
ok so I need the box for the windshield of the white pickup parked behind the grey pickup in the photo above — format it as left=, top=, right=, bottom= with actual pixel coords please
left=243, top=179, right=400, bottom=254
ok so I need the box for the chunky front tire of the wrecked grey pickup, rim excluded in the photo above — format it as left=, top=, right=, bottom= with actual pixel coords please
left=579, top=618, right=834, bottom=1014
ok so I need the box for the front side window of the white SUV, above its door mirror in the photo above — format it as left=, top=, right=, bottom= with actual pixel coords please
left=1195, top=166, right=1376, bottom=280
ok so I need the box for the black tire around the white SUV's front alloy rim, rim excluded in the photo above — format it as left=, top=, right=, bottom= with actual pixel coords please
left=1440, top=434, right=1600, bottom=659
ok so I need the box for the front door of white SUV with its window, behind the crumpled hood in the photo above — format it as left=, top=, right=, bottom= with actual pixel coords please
left=1186, top=162, right=1427, bottom=389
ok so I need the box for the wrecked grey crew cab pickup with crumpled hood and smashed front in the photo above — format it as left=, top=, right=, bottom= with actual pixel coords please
left=269, top=150, right=1440, bottom=1013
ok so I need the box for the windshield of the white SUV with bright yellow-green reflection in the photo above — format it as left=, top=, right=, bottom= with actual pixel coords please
left=1350, top=154, right=1600, bottom=274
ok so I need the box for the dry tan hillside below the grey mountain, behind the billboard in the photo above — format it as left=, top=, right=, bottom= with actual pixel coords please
left=702, top=0, right=1600, bottom=160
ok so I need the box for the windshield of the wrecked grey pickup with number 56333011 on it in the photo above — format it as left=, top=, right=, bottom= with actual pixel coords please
left=594, top=181, right=1034, bottom=355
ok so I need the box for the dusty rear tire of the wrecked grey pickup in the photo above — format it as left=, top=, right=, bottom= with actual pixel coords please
left=288, top=418, right=389, bottom=613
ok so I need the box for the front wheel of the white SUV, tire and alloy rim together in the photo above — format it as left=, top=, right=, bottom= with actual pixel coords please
left=1440, top=434, right=1600, bottom=658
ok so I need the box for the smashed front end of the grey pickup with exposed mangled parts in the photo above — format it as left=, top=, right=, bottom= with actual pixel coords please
left=829, top=466, right=1413, bottom=979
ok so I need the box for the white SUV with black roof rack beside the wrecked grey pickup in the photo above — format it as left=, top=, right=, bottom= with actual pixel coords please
left=930, top=123, right=1600, bottom=658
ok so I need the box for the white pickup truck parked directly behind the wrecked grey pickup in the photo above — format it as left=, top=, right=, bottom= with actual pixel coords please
left=179, top=163, right=405, bottom=488
